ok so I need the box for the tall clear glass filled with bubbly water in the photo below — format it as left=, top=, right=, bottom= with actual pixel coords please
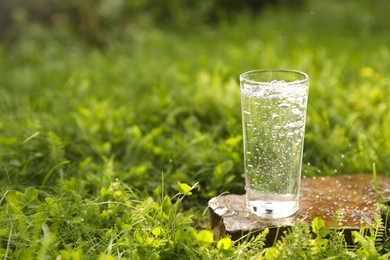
left=240, top=69, right=309, bottom=218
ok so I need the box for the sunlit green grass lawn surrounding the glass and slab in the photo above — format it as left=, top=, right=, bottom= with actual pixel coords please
left=0, top=1, right=390, bottom=259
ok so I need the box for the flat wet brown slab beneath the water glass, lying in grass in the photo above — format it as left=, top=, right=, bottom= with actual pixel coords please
left=208, top=174, right=390, bottom=243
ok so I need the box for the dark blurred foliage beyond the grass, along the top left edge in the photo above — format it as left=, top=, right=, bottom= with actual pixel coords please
left=0, top=0, right=305, bottom=44
